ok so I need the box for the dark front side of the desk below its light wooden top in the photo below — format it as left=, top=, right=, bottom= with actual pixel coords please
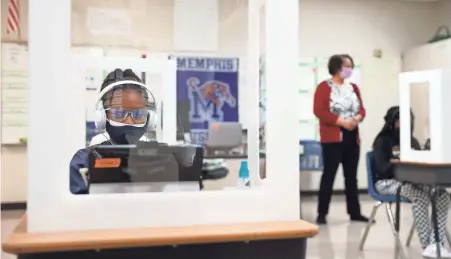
left=18, top=238, right=307, bottom=259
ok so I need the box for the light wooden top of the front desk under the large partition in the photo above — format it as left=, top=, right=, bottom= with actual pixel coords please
left=3, top=216, right=319, bottom=254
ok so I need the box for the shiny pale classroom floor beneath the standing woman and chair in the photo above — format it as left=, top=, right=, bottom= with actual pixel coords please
left=1, top=196, right=451, bottom=259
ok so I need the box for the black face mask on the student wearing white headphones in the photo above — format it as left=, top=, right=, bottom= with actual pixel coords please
left=106, top=121, right=147, bottom=145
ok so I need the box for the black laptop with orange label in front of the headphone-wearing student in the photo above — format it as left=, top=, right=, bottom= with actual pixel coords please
left=88, top=142, right=203, bottom=193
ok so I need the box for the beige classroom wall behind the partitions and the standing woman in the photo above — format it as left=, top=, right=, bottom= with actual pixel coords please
left=1, top=0, right=448, bottom=202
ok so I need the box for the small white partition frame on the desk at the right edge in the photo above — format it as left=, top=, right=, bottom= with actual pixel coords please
left=399, top=70, right=451, bottom=163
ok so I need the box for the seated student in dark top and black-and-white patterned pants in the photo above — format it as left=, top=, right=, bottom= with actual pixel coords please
left=373, top=106, right=451, bottom=258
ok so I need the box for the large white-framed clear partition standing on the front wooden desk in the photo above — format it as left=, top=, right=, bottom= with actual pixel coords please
left=28, top=0, right=299, bottom=232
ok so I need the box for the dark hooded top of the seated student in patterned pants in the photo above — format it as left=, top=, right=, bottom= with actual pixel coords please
left=372, top=106, right=421, bottom=181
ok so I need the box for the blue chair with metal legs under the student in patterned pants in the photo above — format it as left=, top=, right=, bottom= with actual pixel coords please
left=359, top=151, right=451, bottom=255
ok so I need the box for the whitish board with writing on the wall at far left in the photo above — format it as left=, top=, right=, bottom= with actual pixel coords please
left=0, top=43, right=28, bottom=144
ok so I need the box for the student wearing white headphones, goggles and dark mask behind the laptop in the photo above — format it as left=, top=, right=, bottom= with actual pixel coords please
left=70, top=69, right=156, bottom=194
